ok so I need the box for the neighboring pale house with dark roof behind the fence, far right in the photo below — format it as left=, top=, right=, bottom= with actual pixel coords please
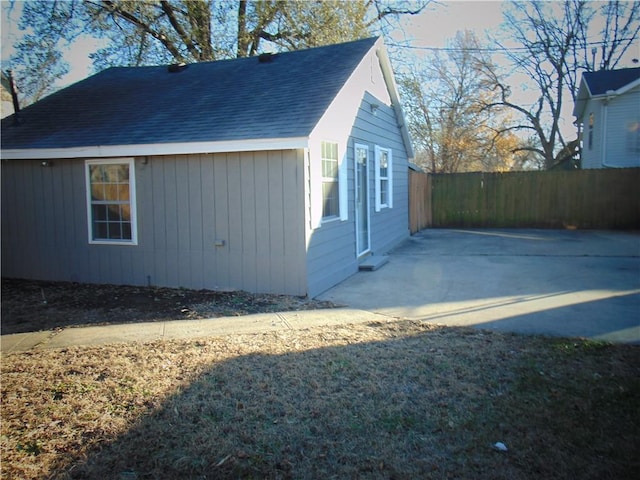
left=573, top=68, right=640, bottom=168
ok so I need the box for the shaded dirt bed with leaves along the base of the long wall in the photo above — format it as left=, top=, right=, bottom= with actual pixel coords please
left=2, top=279, right=335, bottom=335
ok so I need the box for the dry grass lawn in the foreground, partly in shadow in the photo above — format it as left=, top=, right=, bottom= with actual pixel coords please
left=1, top=321, right=640, bottom=480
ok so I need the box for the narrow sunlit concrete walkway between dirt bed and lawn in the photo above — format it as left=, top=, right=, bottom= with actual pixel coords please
left=0, top=308, right=382, bottom=353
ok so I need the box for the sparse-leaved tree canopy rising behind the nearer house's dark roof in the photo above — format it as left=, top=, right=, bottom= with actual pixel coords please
left=3, top=0, right=431, bottom=105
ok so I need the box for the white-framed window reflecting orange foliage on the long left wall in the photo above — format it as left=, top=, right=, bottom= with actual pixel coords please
left=86, top=159, right=137, bottom=245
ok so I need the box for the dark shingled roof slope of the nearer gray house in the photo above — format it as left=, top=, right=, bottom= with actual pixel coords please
left=2, top=38, right=377, bottom=158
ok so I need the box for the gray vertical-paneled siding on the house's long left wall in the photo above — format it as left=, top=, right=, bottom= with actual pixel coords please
left=2, top=150, right=307, bottom=295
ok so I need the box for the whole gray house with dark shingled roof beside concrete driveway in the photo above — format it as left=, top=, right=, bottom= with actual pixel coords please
left=1, top=38, right=413, bottom=297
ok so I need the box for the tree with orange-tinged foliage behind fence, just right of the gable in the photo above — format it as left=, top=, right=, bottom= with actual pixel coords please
left=400, top=31, right=521, bottom=173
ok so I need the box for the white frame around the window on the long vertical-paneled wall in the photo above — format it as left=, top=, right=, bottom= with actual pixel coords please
left=85, top=158, right=138, bottom=245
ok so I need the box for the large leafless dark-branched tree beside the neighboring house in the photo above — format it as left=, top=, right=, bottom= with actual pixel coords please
left=483, top=0, right=640, bottom=168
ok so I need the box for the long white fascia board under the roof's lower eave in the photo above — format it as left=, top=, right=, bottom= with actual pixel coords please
left=0, top=137, right=309, bottom=160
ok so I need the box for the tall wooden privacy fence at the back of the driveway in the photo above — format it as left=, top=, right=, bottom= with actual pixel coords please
left=410, top=168, right=640, bottom=233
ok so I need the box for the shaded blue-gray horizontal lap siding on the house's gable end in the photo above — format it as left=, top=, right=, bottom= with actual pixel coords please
left=307, top=93, right=409, bottom=296
